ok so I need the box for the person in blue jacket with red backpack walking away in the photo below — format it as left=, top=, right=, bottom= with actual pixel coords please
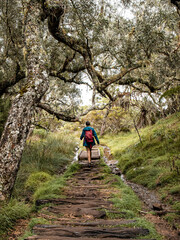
left=80, top=121, right=99, bottom=164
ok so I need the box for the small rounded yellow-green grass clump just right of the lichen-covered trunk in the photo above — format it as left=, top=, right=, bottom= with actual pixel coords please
left=25, top=172, right=52, bottom=191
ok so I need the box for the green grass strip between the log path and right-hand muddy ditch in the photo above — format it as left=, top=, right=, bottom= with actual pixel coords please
left=101, top=162, right=162, bottom=240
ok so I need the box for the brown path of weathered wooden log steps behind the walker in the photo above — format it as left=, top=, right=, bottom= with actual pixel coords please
left=24, top=160, right=155, bottom=240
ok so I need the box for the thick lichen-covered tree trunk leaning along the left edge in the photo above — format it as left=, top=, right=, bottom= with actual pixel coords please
left=0, top=0, right=48, bottom=200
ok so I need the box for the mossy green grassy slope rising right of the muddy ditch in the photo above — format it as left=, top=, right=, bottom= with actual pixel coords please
left=101, top=113, right=180, bottom=225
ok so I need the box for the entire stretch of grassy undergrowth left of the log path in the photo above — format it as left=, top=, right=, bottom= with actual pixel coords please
left=0, top=130, right=79, bottom=240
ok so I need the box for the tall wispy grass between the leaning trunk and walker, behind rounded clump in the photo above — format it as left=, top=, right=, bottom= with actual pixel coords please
left=13, top=130, right=76, bottom=198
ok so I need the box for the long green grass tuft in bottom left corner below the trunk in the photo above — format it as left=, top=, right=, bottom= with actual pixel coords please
left=0, top=200, right=31, bottom=235
